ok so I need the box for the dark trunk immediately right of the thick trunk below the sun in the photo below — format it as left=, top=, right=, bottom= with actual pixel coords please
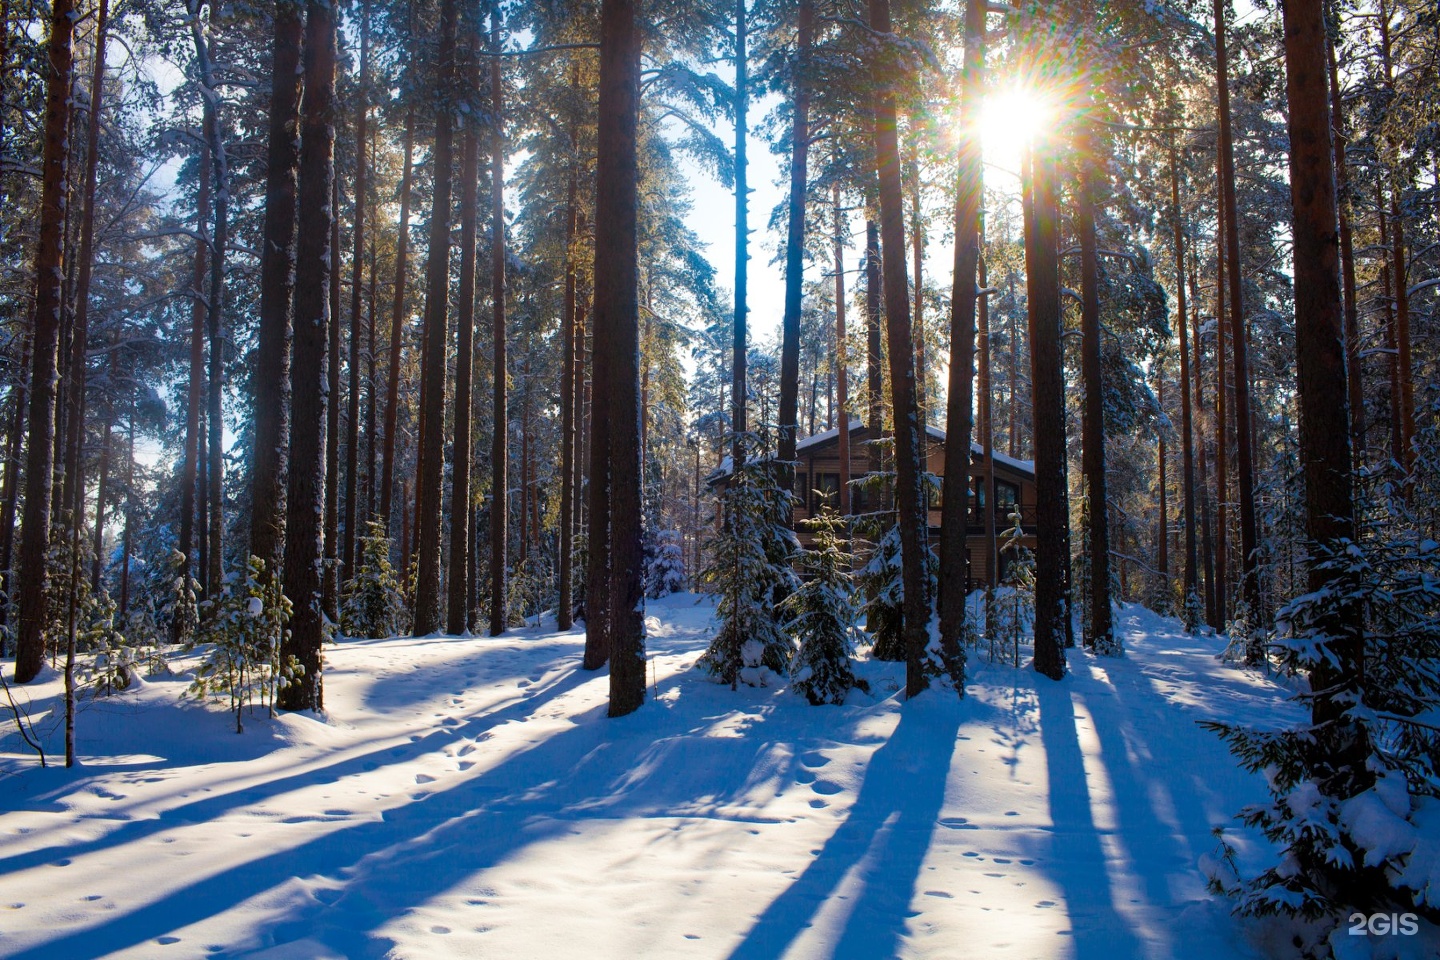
left=1076, top=114, right=1119, bottom=653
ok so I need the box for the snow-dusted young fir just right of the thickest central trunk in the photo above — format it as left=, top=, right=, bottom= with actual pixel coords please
left=698, top=446, right=799, bottom=688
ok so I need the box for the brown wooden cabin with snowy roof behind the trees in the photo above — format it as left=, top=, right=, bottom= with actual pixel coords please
left=708, top=419, right=1035, bottom=589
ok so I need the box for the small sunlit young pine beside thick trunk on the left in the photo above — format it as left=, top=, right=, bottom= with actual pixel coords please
left=187, top=557, right=304, bottom=733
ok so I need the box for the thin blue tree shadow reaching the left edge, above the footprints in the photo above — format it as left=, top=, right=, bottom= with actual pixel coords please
left=0, top=656, right=595, bottom=872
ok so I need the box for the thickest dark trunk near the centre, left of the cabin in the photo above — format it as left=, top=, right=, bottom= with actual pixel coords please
left=590, top=0, right=648, bottom=717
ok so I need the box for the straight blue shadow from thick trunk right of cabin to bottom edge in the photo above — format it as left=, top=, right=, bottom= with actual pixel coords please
left=1035, top=667, right=1146, bottom=960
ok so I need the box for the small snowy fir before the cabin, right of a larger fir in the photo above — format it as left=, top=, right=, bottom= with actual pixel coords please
left=785, top=505, right=867, bottom=705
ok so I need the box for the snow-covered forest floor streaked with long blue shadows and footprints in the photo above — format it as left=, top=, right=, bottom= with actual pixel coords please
left=0, top=594, right=1393, bottom=960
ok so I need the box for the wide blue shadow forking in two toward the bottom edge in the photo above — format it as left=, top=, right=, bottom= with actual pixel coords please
left=730, top=691, right=959, bottom=960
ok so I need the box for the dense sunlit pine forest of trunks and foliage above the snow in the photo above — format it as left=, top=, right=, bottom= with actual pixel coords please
left=0, top=0, right=1440, bottom=938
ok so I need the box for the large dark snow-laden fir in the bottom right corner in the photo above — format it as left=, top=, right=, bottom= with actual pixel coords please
left=1207, top=521, right=1440, bottom=936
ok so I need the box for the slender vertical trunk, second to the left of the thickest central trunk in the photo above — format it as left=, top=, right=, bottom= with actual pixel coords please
left=490, top=1, right=510, bottom=636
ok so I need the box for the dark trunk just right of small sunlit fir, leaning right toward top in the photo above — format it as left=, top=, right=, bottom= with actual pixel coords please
left=413, top=0, right=457, bottom=636
